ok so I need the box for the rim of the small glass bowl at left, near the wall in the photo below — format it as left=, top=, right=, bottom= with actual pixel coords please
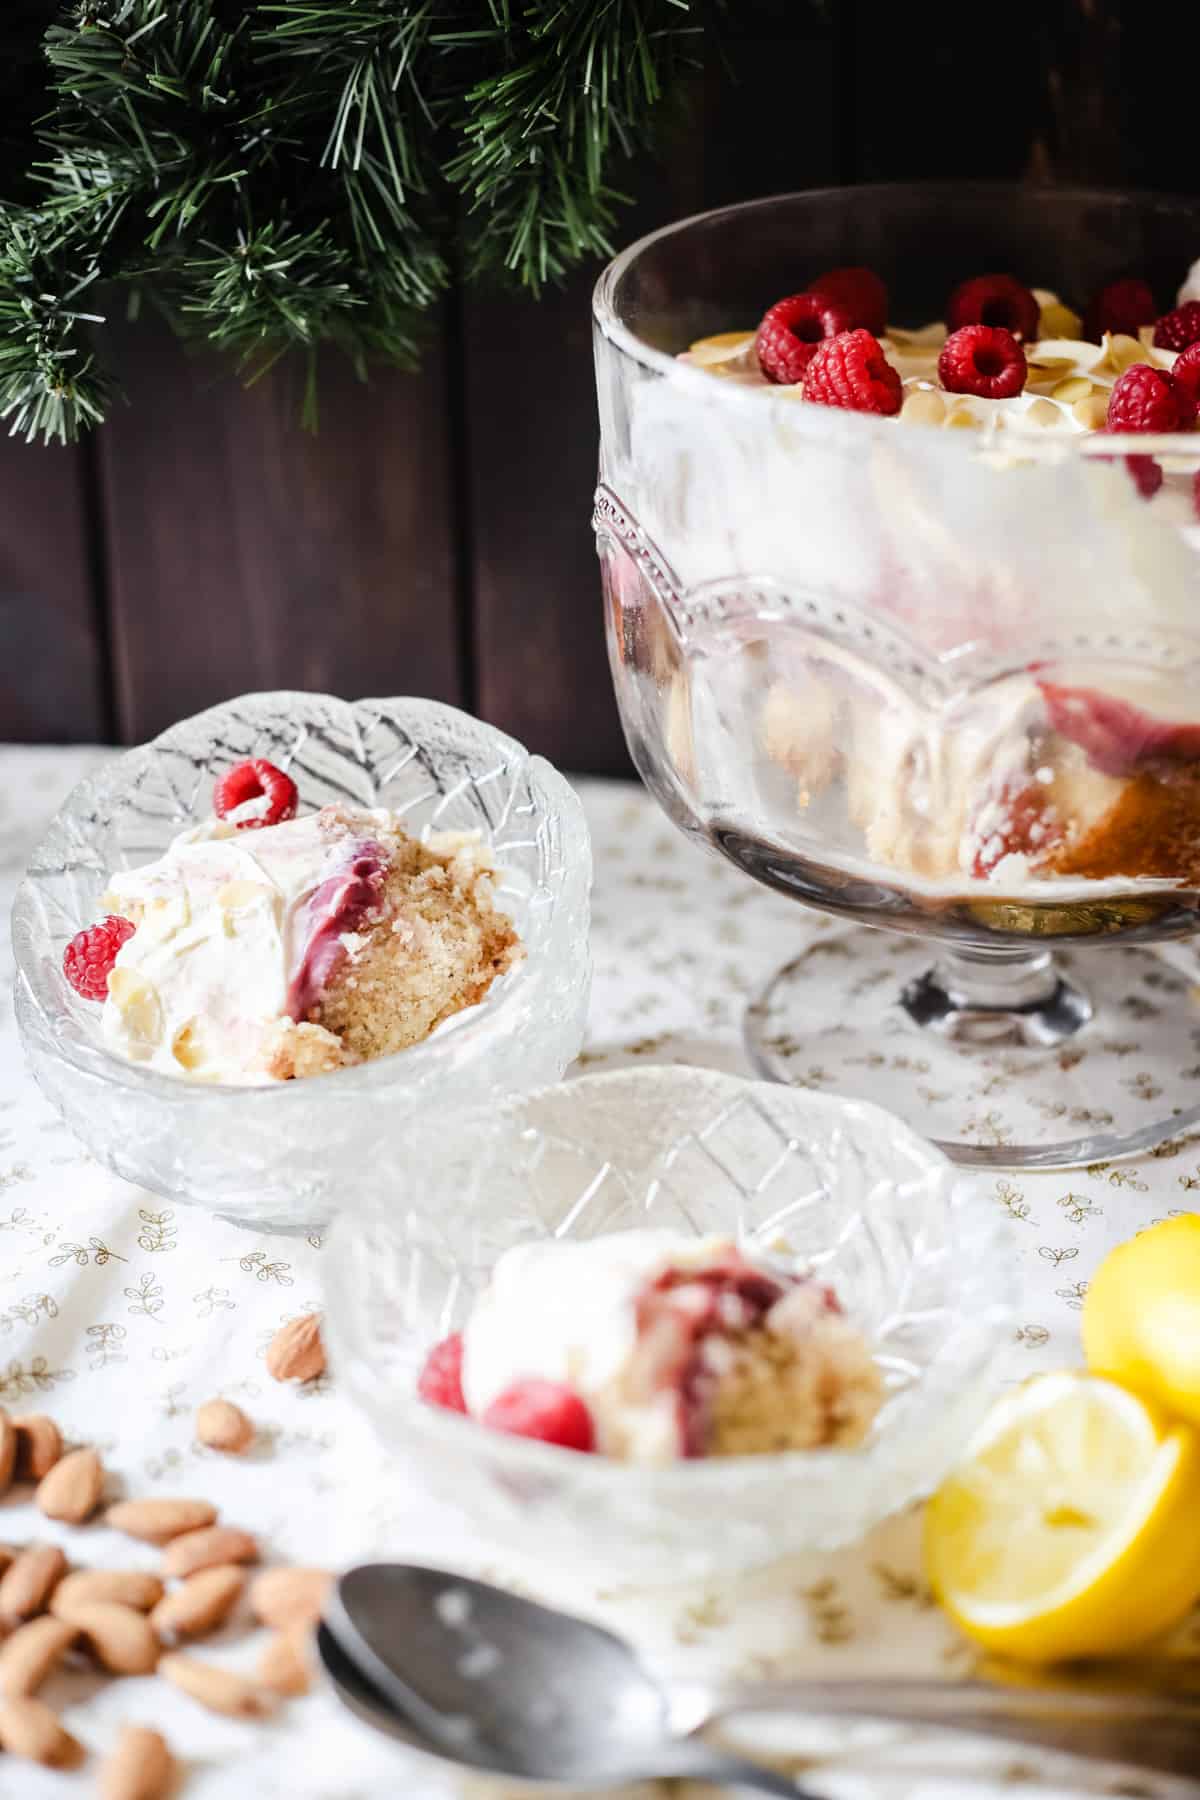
left=13, top=688, right=581, bottom=1107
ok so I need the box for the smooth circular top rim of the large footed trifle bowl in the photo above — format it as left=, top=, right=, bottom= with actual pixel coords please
left=592, top=182, right=1200, bottom=457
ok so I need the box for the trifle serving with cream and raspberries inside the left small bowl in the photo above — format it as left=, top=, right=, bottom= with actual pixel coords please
left=89, top=765, right=518, bottom=1084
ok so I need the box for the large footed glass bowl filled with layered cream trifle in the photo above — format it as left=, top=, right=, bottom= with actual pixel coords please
left=594, top=184, right=1200, bottom=1166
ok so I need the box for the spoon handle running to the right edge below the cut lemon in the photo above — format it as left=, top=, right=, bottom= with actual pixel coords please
left=696, top=1678, right=1200, bottom=1777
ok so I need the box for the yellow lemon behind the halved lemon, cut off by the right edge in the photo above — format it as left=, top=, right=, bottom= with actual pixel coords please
left=1083, top=1213, right=1200, bottom=1424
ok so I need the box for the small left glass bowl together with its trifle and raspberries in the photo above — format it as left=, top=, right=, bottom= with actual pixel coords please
left=13, top=693, right=590, bottom=1229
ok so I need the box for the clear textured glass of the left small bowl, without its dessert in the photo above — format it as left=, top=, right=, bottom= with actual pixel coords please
left=13, top=693, right=592, bottom=1229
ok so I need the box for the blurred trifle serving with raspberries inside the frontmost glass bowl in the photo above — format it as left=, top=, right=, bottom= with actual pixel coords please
left=440, top=1229, right=882, bottom=1465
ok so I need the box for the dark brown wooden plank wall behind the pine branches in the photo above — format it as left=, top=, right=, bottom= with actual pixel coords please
left=0, top=0, right=1200, bottom=772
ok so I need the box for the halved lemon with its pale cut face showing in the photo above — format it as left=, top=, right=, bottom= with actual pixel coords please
left=925, top=1370, right=1200, bottom=1663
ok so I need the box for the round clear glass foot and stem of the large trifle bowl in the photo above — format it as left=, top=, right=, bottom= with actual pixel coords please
left=745, top=927, right=1200, bottom=1168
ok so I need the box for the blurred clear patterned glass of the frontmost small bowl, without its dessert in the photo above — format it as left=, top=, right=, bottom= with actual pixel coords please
left=322, top=1067, right=1016, bottom=1588
